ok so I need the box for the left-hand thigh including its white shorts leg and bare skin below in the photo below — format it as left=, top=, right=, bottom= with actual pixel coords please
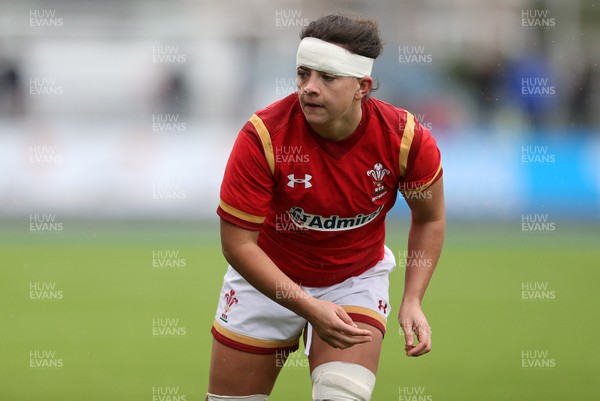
left=208, top=267, right=305, bottom=396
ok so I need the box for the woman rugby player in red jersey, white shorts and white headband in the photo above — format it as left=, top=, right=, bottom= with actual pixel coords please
left=207, top=15, right=445, bottom=401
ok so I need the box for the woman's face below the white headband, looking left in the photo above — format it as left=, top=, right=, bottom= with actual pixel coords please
left=297, top=67, right=365, bottom=127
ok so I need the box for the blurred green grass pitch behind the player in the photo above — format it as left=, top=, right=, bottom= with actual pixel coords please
left=0, top=221, right=600, bottom=401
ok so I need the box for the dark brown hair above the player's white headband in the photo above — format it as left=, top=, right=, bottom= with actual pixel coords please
left=300, top=14, right=383, bottom=58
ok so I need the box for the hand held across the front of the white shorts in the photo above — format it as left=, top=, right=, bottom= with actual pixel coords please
left=308, top=299, right=373, bottom=349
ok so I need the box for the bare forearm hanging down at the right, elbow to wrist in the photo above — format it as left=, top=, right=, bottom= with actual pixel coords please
left=402, top=217, right=446, bottom=305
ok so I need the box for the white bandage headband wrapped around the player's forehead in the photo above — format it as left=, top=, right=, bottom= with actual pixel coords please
left=296, top=37, right=375, bottom=78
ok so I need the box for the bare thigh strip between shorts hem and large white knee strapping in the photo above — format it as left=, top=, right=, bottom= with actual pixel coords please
left=308, top=322, right=383, bottom=374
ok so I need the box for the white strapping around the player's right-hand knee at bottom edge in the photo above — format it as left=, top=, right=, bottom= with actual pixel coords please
left=311, top=362, right=375, bottom=401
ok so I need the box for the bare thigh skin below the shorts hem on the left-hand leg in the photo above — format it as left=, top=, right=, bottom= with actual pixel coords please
left=208, top=339, right=290, bottom=396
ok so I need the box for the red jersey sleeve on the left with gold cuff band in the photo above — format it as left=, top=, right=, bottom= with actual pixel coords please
left=217, top=124, right=274, bottom=230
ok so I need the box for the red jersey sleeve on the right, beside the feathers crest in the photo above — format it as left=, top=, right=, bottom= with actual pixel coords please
left=399, top=116, right=443, bottom=193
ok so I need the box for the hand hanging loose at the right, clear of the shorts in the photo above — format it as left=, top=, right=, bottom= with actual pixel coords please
left=398, top=302, right=431, bottom=356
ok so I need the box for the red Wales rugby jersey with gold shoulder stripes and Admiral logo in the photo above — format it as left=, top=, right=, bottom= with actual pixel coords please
left=217, top=94, right=442, bottom=287
